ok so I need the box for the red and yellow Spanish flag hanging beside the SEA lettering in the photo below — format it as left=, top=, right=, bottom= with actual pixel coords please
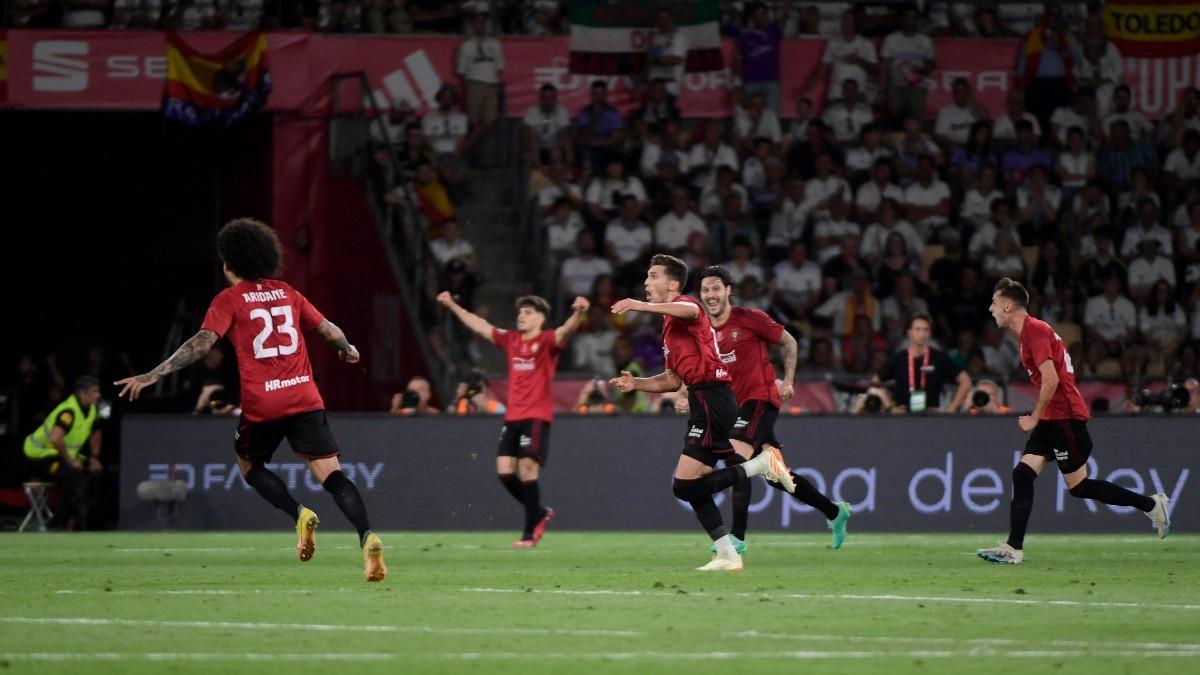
left=162, top=32, right=271, bottom=126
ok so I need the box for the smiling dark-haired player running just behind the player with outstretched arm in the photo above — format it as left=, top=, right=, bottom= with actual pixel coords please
left=700, top=267, right=851, bottom=554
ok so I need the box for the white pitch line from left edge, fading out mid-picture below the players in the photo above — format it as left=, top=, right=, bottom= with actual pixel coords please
left=0, top=616, right=644, bottom=638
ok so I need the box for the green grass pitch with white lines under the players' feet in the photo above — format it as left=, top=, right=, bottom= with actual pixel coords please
left=0, top=530, right=1200, bottom=675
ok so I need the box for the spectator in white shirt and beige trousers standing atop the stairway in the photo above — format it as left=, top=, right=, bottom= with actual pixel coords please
left=455, top=12, right=504, bottom=154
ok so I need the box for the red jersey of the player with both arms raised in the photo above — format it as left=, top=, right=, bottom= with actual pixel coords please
left=492, top=328, right=563, bottom=422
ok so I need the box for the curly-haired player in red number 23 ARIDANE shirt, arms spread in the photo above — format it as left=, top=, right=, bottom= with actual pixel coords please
left=116, top=219, right=388, bottom=581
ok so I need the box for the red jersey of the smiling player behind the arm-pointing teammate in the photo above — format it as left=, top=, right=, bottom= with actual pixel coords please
left=716, top=307, right=784, bottom=407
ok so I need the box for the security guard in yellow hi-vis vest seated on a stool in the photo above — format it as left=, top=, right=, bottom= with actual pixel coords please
left=25, top=375, right=101, bottom=522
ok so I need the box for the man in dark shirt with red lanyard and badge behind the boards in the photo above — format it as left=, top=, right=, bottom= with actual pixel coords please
left=871, top=312, right=971, bottom=414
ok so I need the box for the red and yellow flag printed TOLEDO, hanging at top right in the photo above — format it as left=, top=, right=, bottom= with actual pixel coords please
left=1103, top=0, right=1200, bottom=59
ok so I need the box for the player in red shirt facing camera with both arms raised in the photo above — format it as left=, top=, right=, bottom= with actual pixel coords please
left=438, top=292, right=589, bottom=549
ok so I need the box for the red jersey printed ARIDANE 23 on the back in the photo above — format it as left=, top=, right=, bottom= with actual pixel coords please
left=200, top=279, right=325, bottom=422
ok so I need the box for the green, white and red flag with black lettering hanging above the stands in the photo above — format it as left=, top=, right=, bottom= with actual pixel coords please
left=569, top=0, right=725, bottom=74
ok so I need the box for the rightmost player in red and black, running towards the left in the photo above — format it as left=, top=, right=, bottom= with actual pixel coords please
left=976, top=277, right=1171, bottom=565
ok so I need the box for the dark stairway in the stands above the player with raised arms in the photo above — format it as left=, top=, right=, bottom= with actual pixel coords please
left=457, top=167, right=528, bottom=375
